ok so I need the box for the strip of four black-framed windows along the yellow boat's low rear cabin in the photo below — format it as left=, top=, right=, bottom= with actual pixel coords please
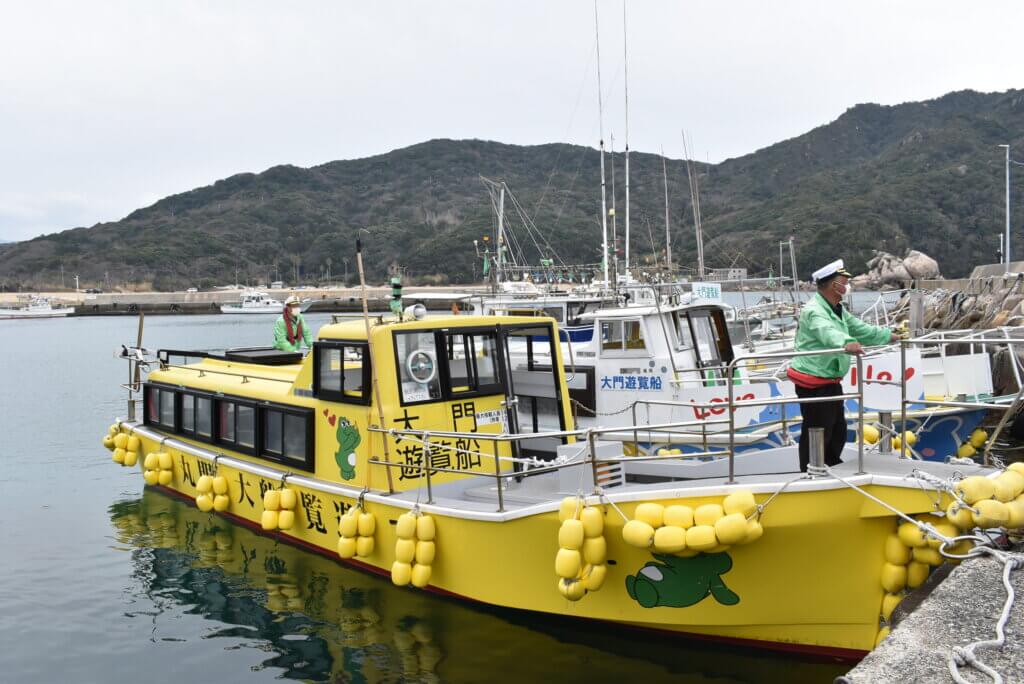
left=143, top=384, right=315, bottom=472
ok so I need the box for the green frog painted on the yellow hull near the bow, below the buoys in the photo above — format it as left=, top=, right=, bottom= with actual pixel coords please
left=626, top=553, right=739, bottom=608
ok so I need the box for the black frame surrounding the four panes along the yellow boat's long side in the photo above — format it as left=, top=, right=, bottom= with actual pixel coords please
left=142, top=382, right=316, bottom=473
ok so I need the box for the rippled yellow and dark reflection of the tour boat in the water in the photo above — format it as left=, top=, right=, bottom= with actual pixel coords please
left=110, top=490, right=847, bottom=682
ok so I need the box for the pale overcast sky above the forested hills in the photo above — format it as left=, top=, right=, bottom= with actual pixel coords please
left=0, top=0, right=1024, bottom=240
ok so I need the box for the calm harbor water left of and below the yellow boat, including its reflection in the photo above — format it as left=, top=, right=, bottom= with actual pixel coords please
left=0, top=311, right=849, bottom=683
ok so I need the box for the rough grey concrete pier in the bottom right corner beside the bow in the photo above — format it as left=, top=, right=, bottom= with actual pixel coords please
left=836, top=547, right=1024, bottom=684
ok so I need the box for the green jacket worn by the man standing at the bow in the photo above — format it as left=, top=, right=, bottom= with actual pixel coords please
left=790, top=293, right=892, bottom=378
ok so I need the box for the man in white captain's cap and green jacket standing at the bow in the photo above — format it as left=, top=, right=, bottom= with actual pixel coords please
left=787, top=259, right=899, bottom=471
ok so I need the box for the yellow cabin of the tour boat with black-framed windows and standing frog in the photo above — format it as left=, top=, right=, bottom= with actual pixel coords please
left=143, top=315, right=573, bottom=490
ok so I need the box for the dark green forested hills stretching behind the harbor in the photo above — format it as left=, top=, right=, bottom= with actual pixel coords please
left=0, top=90, right=1024, bottom=289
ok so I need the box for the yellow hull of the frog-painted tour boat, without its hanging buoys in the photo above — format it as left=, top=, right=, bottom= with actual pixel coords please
left=119, top=421, right=958, bottom=657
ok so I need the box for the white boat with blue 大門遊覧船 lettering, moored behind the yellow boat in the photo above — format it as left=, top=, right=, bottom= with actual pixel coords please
left=509, top=301, right=1012, bottom=460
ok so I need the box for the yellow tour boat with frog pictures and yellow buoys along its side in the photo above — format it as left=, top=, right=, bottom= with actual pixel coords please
left=103, top=312, right=1024, bottom=658
